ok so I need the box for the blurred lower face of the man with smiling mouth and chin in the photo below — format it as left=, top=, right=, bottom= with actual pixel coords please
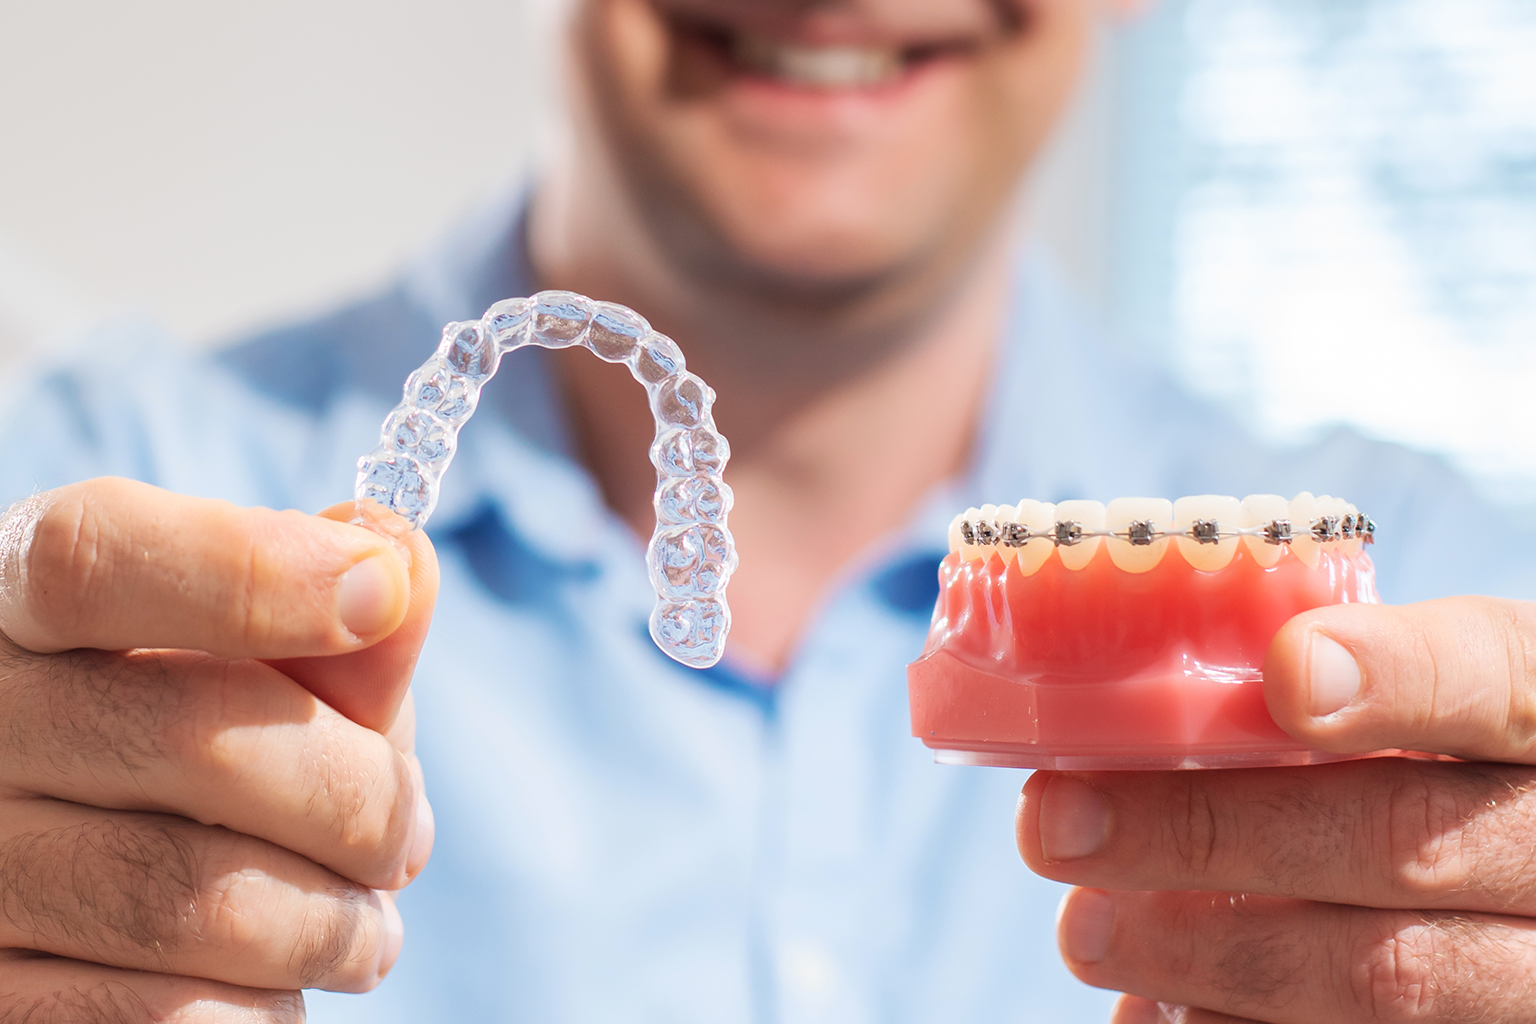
left=576, top=0, right=1092, bottom=295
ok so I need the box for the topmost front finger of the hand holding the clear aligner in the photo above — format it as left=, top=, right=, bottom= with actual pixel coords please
left=0, top=477, right=412, bottom=659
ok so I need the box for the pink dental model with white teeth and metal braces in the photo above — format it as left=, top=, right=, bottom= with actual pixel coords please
left=908, top=493, right=1379, bottom=769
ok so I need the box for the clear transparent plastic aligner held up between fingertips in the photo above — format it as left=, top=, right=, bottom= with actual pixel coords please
left=355, top=292, right=736, bottom=668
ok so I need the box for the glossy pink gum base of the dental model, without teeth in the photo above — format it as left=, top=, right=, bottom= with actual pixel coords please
left=908, top=548, right=1379, bottom=769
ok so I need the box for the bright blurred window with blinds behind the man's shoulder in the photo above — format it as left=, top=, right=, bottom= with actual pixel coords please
left=1120, top=0, right=1536, bottom=504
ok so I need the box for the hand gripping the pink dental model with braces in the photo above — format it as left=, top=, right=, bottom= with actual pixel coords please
left=1017, top=597, right=1536, bottom=1024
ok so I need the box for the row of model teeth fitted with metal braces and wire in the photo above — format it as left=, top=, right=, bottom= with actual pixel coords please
left=949, top=491, right=1376, bottom=571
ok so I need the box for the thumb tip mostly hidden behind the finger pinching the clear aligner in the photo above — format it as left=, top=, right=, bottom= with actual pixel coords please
left=267, top=502, right=438, bottom=732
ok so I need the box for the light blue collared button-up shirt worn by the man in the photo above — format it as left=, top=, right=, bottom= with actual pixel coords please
left=0, top=196, right=1536, bottom=1024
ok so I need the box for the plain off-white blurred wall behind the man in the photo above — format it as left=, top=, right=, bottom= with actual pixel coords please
left=0, top=0, right=1109, bottom=364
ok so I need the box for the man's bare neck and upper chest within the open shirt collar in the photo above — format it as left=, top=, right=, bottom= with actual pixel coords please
left=530, top=163, right=1008, bottom=672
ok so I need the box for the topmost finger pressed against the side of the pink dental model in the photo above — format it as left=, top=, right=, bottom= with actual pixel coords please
left=1264, top=597, right=1536, bottom=765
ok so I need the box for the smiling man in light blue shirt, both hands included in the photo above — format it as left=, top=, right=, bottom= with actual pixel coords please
left=0, top=0, right=1536, bottom=1022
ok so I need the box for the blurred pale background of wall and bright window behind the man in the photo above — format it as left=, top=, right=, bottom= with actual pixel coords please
left=0, top=0, right=1536, bottom=520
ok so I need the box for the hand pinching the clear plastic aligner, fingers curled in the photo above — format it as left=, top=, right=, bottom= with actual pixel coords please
left=0, top=477, right=438, bottom=1024
